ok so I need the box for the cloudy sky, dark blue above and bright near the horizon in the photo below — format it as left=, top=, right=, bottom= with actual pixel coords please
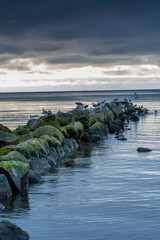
left=0, top=0, right=160, bottom=92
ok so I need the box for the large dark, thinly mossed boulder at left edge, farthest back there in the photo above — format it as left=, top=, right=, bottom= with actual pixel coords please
left=0, top=130, right=19, bottom=147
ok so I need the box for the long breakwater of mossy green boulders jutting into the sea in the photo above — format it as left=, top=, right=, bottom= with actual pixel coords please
left=0, top=99, right=148, bottom=240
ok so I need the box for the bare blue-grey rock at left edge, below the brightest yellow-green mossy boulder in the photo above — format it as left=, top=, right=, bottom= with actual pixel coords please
left=0, top=174, right=12, bottom=199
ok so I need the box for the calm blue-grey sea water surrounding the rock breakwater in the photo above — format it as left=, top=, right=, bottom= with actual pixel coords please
left=0, top=90, right=160, bottom=240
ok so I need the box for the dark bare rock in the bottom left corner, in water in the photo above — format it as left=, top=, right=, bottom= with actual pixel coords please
left=0, top=221, right=30, bottom=240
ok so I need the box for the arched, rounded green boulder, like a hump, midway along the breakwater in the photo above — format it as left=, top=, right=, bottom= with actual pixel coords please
left=33, top=126, right=64, bottom=143
